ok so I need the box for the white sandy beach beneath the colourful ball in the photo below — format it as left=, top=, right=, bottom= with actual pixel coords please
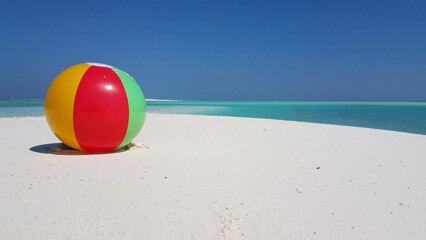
left=0, top=114, right=426, bottom=240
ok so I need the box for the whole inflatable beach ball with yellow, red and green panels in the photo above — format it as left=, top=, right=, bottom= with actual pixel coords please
left=44, top=63, right=146, bottom=153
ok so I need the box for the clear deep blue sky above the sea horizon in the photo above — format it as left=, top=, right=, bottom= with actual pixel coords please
left=0, top=0, right=426, bottom=101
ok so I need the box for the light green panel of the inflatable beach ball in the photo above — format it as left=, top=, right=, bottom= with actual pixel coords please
left=112, top=67, right=146, bottom=149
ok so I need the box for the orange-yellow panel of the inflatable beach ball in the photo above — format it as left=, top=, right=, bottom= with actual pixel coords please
left=44, top=63, right=90, bottom=150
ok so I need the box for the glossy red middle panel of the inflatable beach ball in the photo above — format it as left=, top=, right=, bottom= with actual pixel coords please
left=73, top=66, right=129, bottom=153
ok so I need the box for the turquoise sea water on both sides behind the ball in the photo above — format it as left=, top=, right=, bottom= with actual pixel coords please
left=0, top=100, right=426, bottom=135
